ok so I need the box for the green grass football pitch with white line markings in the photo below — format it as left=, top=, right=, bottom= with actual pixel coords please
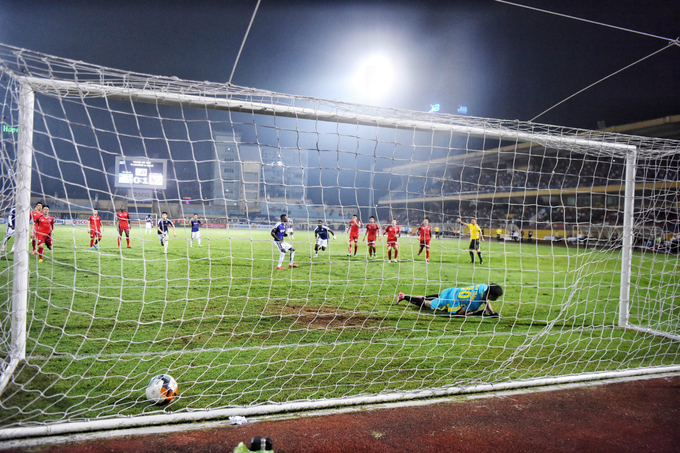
left=0, top=226, right=680, bottom=425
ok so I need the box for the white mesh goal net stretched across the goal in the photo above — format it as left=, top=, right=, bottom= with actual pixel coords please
left=0, top=46, right=680, bottom=438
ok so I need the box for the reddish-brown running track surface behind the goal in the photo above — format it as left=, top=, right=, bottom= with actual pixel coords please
left=6, top=376, right=680, bottom=453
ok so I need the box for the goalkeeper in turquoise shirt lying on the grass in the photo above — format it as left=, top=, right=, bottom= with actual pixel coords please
left=396, top=283, right=503, bottom=318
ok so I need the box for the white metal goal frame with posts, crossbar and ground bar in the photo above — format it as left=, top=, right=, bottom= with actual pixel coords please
left=0, top=76, right=680, bottom=439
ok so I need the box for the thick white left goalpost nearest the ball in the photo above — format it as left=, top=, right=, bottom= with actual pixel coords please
left=0, top=84, right=35, bottom=395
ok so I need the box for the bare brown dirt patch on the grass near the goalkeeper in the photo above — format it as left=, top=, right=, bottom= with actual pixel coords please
left=278, top=305, right=370, bottom=329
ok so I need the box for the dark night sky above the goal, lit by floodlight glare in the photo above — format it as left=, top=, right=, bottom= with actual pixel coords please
left=0, top=0, right=680, bottom=128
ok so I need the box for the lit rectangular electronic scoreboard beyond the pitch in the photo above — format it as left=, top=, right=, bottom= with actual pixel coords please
left=115, top=156, right=167, bottom=190
